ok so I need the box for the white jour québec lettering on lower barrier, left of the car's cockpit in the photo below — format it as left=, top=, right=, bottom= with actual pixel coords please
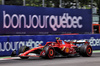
left=0, top=39, right=43, bottom=51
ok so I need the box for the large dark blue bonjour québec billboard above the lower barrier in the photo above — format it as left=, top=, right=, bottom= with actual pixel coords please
left=0, top=5, right=92, bottom=34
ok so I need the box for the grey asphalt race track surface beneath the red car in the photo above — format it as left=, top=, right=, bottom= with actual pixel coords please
left=0, top=51, right=100, bottom=66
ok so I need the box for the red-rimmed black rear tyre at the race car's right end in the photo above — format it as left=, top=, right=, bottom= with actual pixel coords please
left=80, top=45, right=92, bottom=57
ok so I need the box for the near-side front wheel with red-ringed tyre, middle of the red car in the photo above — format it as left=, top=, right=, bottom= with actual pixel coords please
left=43, top=46, right=55, bottom=59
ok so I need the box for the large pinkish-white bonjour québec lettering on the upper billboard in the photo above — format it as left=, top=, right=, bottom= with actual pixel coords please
left=3, top=11, right=83, bottom=31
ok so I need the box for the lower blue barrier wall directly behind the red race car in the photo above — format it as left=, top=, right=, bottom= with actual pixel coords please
left=0, top=34, right=100, bottom=56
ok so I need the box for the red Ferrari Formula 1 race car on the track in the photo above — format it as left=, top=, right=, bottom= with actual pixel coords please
left=11, top=39, right=92, bottom=59
